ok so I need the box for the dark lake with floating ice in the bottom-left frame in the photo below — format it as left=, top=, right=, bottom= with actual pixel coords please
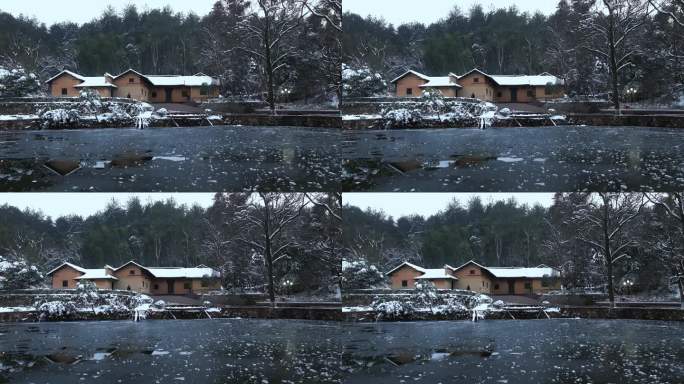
left=0, top=319, right=343, bottom=384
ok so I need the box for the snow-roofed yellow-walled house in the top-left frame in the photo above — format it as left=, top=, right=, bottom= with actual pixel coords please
left=47, top=69, right=220, bottom=103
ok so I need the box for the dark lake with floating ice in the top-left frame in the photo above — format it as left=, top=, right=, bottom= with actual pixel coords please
left=0, top=126, right=342, bottom=192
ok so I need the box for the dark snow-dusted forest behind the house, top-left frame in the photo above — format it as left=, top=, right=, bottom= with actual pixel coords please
left=0, top=0, right=342, bottom=101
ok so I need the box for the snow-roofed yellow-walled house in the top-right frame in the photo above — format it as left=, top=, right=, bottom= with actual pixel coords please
left=392, top=69, right=565, bottom=103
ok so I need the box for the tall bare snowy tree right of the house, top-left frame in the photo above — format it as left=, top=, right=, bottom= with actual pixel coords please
left=237, top=0, right=306, bottom=113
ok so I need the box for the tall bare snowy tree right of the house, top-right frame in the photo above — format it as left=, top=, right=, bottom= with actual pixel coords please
left=581, top=0, right=650, bottom=113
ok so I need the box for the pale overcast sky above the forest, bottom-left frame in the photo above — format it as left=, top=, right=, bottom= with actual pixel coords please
left=0, top=193, right=214, bottom=219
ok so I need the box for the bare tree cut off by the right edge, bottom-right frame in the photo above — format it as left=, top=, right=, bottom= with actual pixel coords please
left=645, top=192, right=684, bottom=308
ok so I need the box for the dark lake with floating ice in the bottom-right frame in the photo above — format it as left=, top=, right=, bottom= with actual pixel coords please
left=343, top=319, right=684, bottom=384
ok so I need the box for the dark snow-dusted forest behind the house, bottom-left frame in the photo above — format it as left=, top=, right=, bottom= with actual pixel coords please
left=0, top=193, right=341, bottom=296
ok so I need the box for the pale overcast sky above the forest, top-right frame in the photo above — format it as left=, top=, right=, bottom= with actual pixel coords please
left=342, top=0, right=558, bottom=26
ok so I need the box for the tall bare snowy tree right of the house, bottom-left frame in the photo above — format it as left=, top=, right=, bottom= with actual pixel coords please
left=232, top=193, right=308, bottom=304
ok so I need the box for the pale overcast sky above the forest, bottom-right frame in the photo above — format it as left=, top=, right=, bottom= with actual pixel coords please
left=342, top=193, right=553, bottom=219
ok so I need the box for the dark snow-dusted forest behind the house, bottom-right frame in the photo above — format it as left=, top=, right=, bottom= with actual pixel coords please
left=343, top=193, right=684, bottom=304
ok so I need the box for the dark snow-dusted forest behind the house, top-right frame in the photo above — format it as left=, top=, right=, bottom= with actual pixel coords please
left=343, top=0, right=684, bottom=105
